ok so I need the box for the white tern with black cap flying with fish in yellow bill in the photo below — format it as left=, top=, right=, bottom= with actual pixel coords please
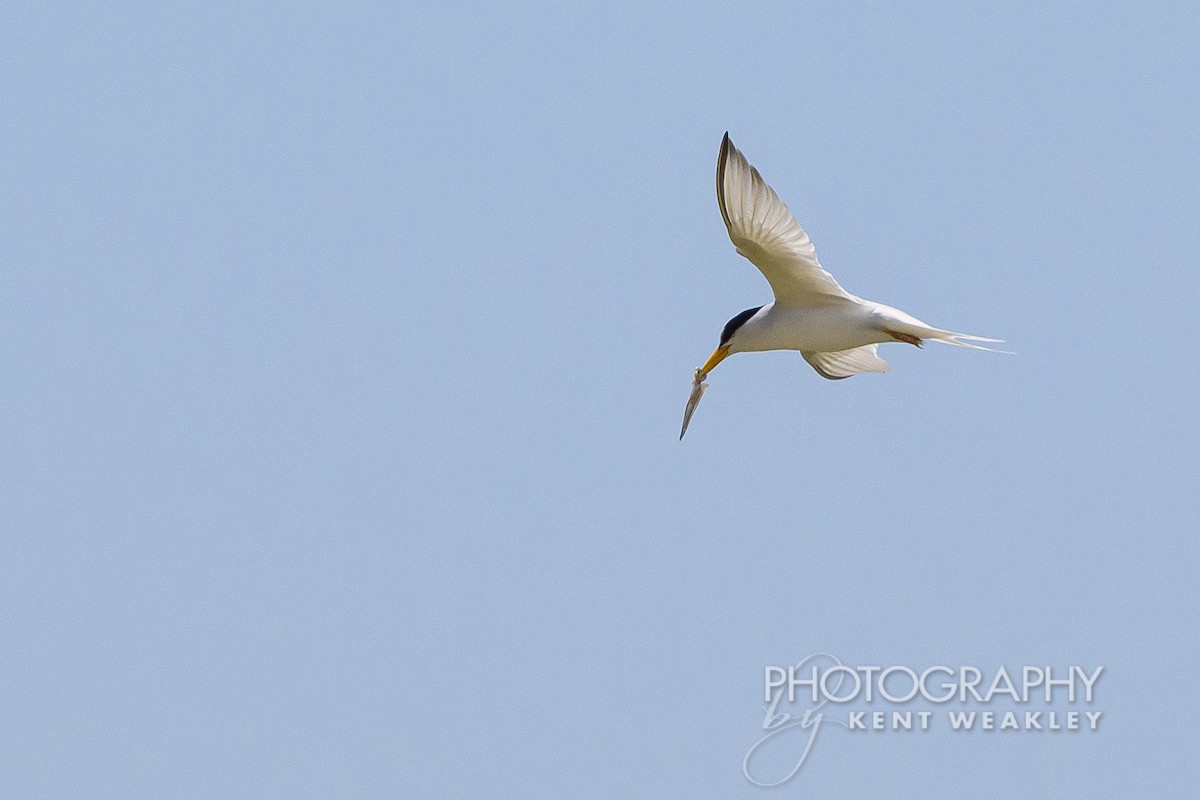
left=679, top=131, right=1003, bottom=440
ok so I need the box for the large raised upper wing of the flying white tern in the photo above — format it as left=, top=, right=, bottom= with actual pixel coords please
left=716, top=133, right=853, bottom=306
